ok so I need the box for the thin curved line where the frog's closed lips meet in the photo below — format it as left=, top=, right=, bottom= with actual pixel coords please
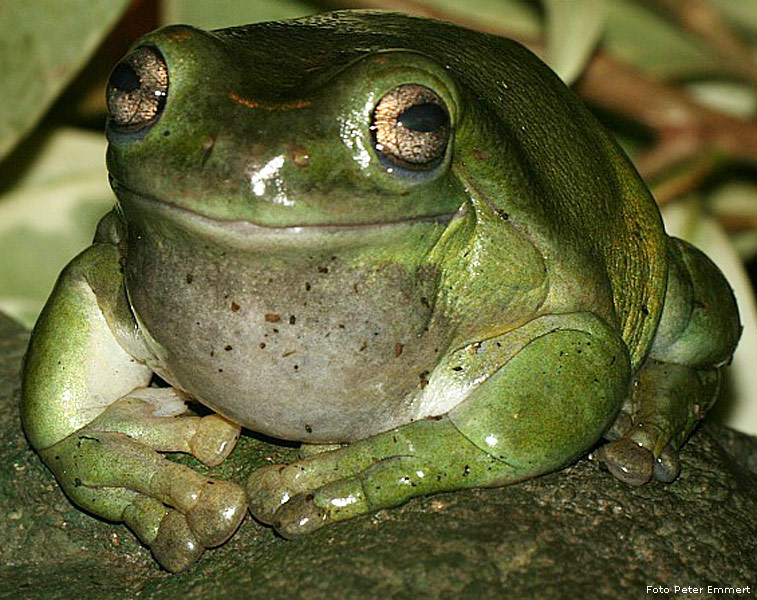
left=109, top=175, right=466, bottom=233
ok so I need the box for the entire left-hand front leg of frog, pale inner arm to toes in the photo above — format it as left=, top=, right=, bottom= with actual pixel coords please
left=22, top=243, right=246, bottom=571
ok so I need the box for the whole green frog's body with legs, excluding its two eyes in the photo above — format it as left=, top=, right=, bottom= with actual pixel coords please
left=22, top=12, right=740, bottom=571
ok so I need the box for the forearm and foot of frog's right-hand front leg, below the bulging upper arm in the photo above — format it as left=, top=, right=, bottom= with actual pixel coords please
left=247, top=417, right=508, bottom=538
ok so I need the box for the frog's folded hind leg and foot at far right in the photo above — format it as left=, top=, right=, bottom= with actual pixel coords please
left=598, top=238, right=741, bottom=485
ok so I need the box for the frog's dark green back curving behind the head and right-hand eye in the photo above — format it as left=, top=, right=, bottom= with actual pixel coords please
left=213, top=11, right=667, bottom=367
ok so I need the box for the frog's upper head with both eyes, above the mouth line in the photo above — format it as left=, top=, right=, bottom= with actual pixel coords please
left=107, top=12, right=482, bottom=234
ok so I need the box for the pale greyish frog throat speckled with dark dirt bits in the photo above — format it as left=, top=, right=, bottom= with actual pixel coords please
left=126, top=216, right=451, bottom=442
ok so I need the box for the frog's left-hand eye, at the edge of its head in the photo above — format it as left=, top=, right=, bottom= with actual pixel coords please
left=107, top=46, right=168, bottom=127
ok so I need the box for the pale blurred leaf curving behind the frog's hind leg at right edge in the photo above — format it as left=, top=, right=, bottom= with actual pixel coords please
left=663, top=198, right=757, bottom=435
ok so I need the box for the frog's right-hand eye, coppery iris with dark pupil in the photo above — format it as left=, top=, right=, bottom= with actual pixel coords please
left=371, top=83, right=450, bottom=170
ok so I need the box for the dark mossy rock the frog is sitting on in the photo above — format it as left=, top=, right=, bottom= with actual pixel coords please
left=0, top=316, right=757, bottom=600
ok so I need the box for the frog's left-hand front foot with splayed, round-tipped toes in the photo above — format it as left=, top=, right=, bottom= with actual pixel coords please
left=41, top=392, right=246, bottom=572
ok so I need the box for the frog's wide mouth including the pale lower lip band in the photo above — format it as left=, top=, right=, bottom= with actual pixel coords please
left=110, top=182, right=467, bottom=247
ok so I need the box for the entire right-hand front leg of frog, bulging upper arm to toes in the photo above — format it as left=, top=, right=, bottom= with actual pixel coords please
left=247, top=313, right=630, bottom=536
